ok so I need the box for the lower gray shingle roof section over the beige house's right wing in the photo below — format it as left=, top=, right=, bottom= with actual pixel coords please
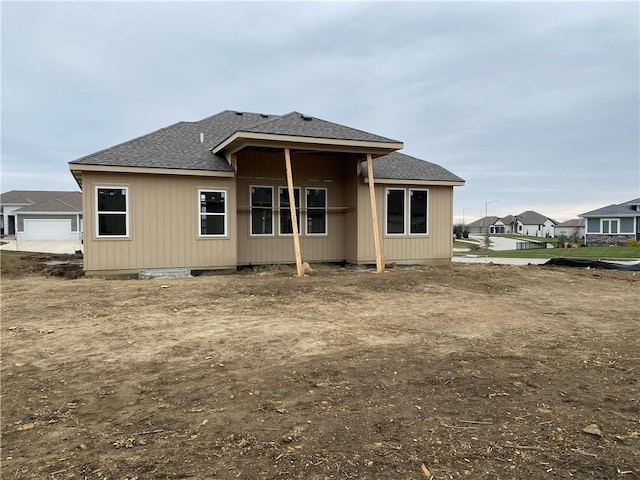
left=362, top=152, right=464, bottom=182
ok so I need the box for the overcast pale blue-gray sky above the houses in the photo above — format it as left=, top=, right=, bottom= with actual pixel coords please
left=1, top=1, right=640, bottom=223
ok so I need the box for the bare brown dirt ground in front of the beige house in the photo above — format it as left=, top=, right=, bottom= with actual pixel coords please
left=1, top=253, right=640, bottom=480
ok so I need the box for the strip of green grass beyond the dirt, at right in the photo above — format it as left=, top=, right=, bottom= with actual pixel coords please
left=456, top=247, right=640, bottom=261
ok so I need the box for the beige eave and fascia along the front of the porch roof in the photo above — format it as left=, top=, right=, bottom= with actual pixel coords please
left=211, top=132, right=404, bottom=155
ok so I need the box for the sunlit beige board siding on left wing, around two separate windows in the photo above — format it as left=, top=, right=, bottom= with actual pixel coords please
left=82, top=172, right=237, bottom=275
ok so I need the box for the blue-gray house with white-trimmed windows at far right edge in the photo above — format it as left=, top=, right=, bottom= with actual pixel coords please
left=580, top=198, right=640, bottom=246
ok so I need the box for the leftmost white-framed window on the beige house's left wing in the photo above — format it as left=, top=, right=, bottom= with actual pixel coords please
left=96, top=187, right=129, bottom=237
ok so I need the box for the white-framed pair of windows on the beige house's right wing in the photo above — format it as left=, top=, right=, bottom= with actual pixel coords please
left=386, top=188, right=429, bottom=235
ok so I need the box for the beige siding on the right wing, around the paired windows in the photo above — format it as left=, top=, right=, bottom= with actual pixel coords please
left=357, top=181, right=453, bottom=264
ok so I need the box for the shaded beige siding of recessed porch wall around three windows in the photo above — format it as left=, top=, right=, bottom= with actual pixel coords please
left=237, top=150, right=357, bottom=264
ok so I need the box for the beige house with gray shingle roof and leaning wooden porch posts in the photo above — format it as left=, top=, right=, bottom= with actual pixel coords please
left=69, top=110, right=464, bottom=275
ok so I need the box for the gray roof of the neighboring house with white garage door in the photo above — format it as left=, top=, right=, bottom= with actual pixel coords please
left=0, top=190, right=82, bottom=213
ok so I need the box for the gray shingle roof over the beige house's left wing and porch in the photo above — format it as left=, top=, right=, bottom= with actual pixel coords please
left=69, top=110, right=396, bottom=172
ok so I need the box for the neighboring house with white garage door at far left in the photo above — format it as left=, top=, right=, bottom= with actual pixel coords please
left=0, top=190, right=82, bottom=240
